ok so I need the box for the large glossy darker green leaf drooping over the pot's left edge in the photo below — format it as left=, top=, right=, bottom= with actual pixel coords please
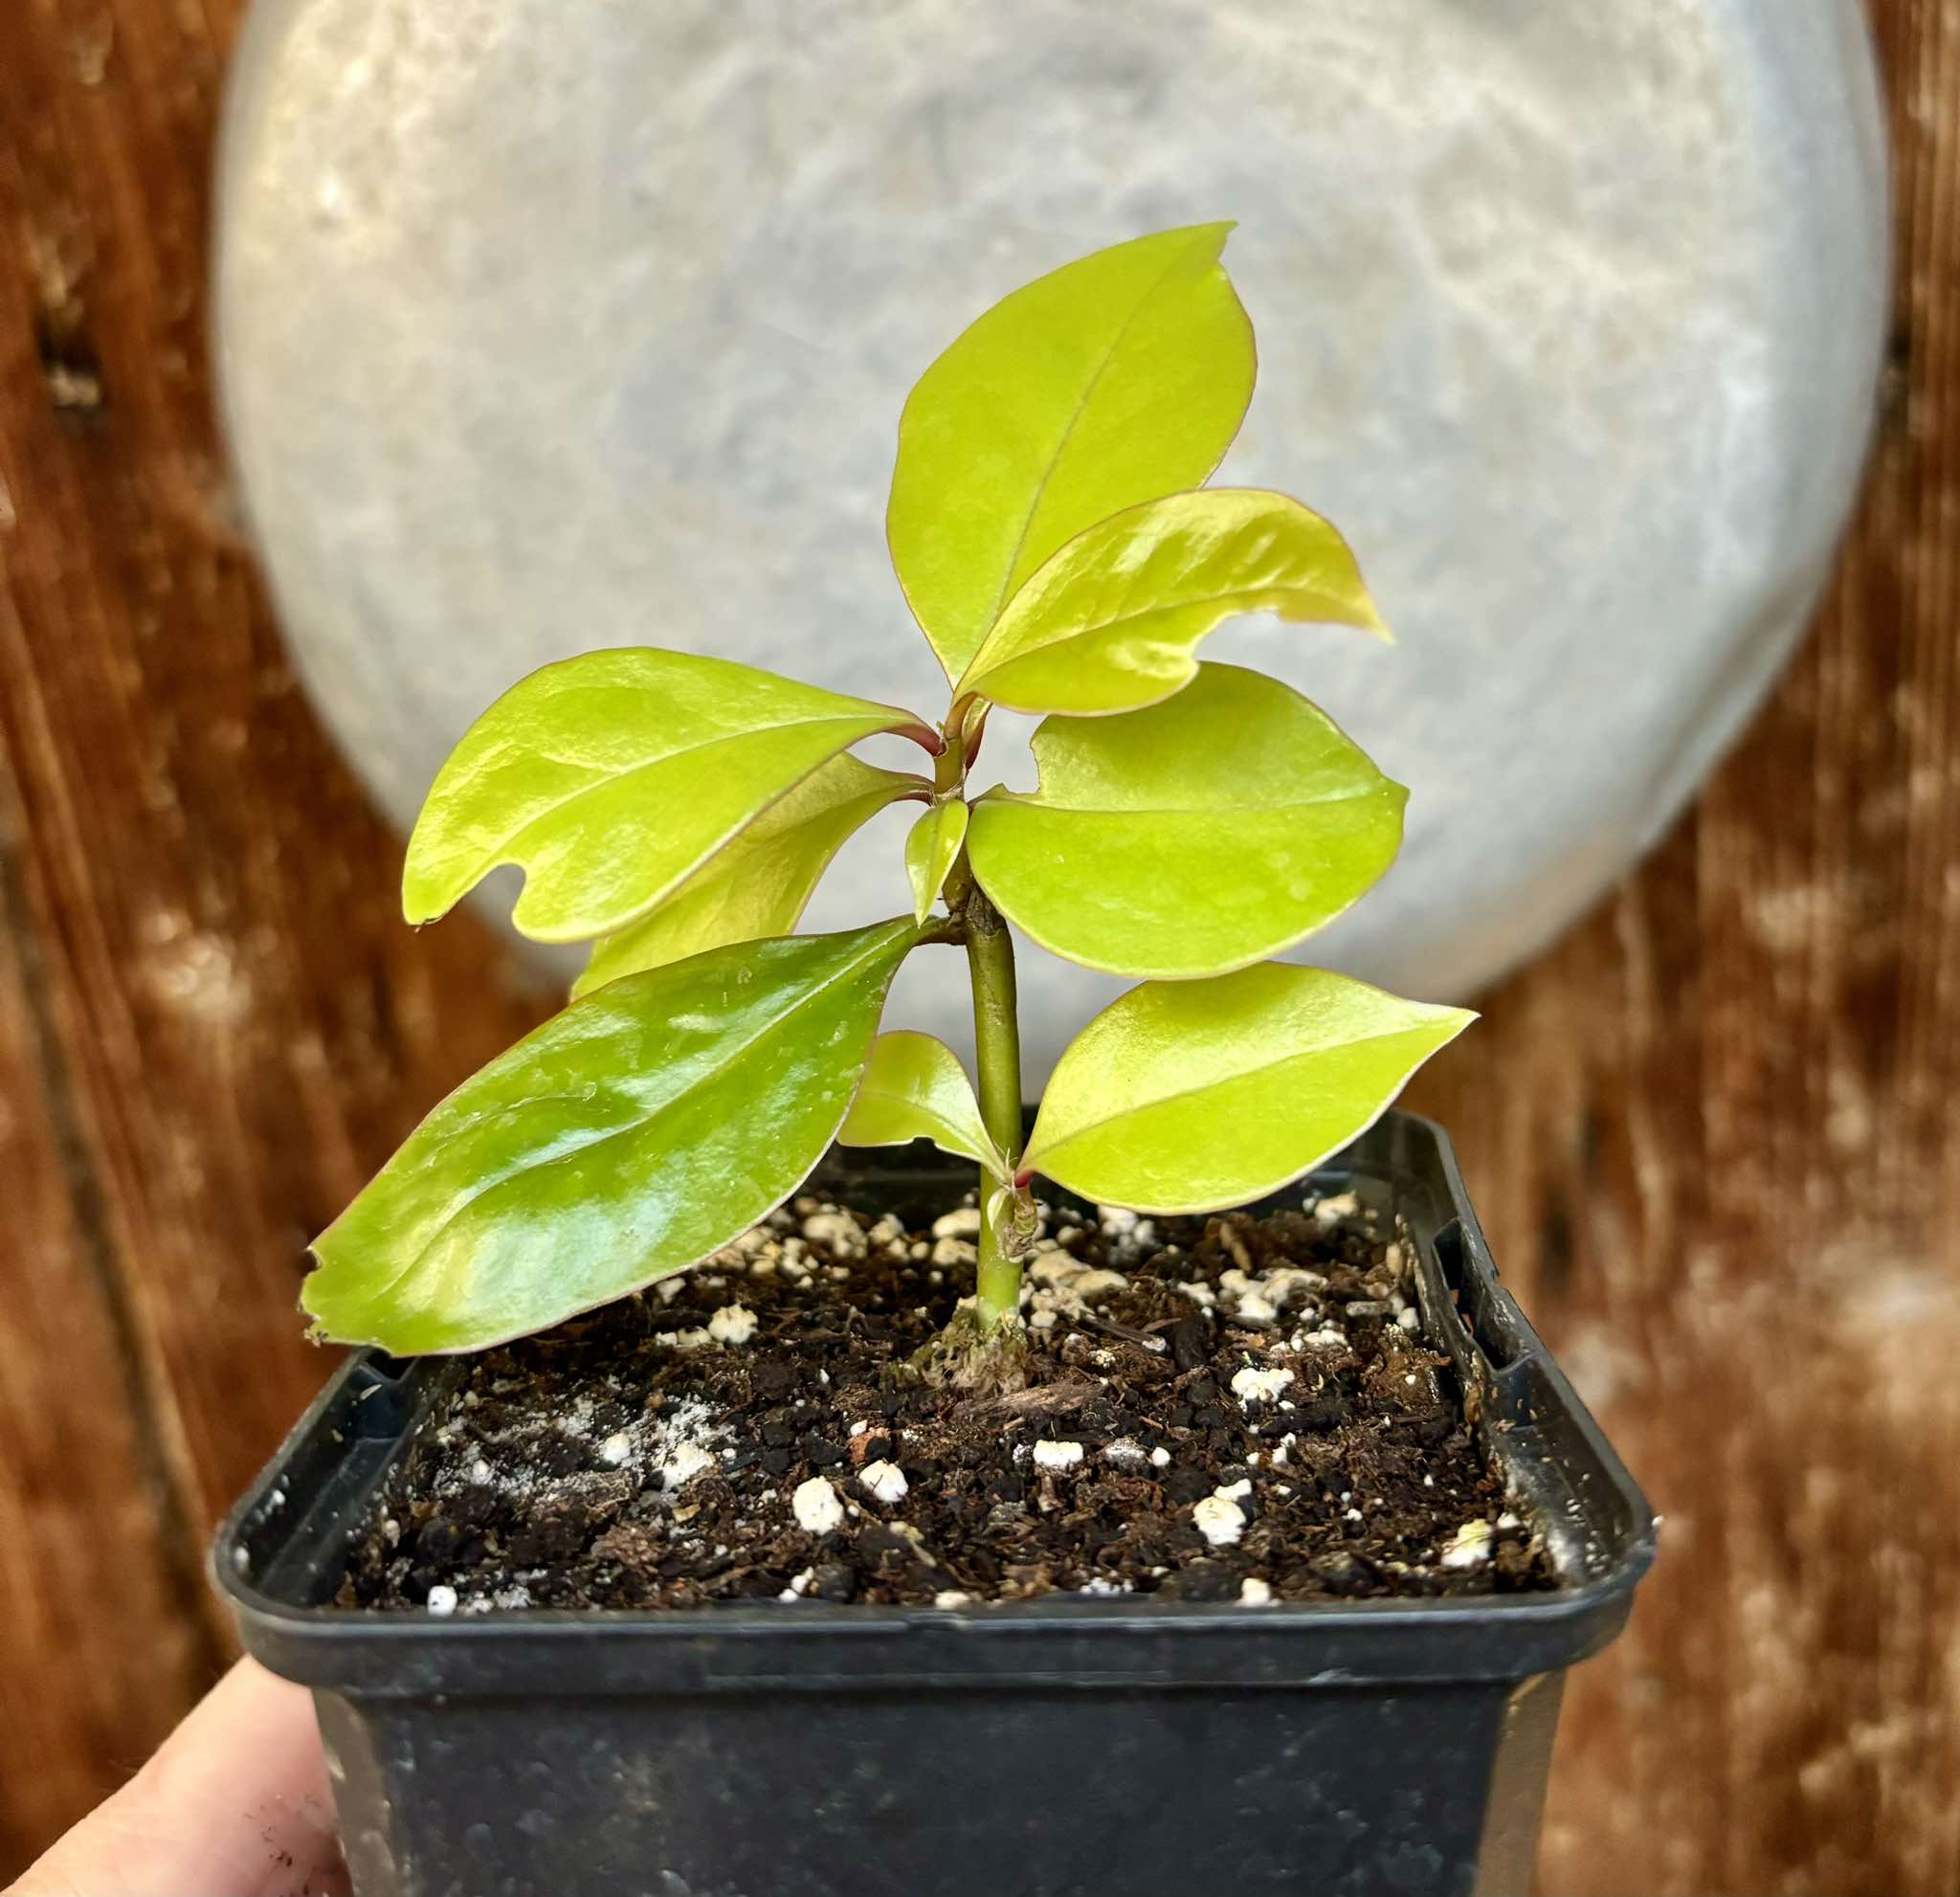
left=300, top=921, right=917, bottom=1356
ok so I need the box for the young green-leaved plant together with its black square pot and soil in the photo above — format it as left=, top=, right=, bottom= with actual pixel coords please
left=217, top=225, right=1652, bottom=1897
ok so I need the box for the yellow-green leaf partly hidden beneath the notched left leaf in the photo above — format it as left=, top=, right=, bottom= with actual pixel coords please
left=572, top=752, right=925, bottom=999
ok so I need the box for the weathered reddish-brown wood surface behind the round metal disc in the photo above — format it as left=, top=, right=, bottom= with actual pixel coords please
left=0, top=0, right=1960, bottom=1897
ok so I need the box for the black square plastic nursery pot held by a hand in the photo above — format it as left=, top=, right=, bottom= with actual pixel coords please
left=215, top=1113, right=1655, bottom=1897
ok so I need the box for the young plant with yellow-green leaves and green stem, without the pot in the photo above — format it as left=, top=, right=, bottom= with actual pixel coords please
left=303, top=223, right=1472, bottom=1368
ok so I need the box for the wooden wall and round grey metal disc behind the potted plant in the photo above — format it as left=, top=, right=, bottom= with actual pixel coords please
left=0, top=0, right=1960, bottom=1897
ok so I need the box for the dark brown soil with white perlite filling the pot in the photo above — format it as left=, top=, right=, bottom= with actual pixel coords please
left=339, top=1199, right=1552, bottom=1613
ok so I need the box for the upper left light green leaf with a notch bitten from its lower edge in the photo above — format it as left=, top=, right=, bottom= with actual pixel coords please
left=402, top=647, right=924, bottom=943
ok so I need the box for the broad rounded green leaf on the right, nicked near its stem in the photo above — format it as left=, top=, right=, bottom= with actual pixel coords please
left=967, top=664, right=1407, bottom=978
